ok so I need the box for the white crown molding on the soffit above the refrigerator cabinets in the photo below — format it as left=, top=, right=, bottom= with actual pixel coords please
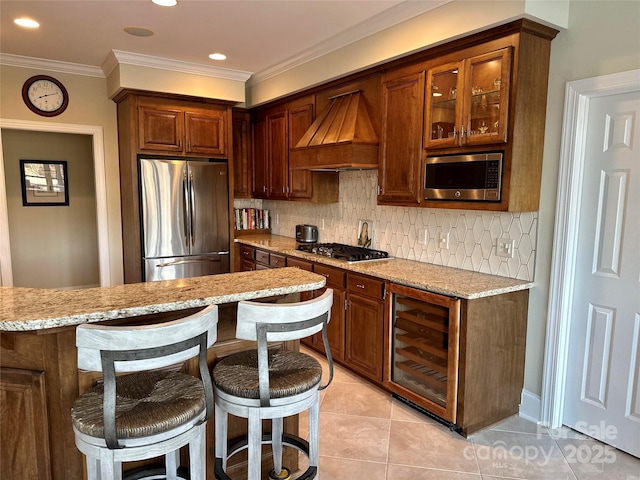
left=102, top=50, right=253, bottom=82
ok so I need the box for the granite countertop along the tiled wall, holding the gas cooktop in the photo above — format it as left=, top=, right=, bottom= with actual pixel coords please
left=235, top=234, right=534, bottom=300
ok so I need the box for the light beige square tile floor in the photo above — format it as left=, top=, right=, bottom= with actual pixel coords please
left=300, top=349, right=640, bottom=480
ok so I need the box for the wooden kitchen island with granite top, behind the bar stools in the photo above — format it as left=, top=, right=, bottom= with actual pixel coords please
left=0, top=268, right=325, bottom=480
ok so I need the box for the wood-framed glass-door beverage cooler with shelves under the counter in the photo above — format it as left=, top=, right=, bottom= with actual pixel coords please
left=388, top=284, right=460, bottom=425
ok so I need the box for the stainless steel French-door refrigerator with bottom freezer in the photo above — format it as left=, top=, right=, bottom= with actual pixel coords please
left=140, top=159, right=230, bottom=282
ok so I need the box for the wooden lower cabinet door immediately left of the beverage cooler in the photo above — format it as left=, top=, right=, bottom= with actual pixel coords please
left=345, top=292, right=384, bottom=383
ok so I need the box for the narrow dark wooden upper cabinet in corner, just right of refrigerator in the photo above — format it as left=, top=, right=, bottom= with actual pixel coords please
left=231, top=109, right=252, bottom=198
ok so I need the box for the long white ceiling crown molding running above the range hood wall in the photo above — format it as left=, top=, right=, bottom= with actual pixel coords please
left=247, top=0, right=454, bottom=86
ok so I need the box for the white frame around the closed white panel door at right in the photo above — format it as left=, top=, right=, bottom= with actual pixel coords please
left=540, top=69, right=640, bottom=428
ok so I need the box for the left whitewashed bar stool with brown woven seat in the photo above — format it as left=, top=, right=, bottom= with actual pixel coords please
left=71, top=305, right=218, bottom=480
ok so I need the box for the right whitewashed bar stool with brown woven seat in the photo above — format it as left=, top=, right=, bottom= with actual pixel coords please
left=213, top=289, right=333, bottom=480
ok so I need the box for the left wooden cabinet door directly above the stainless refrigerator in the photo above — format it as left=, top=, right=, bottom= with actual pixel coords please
left=138, top=105, right=184, bottom=153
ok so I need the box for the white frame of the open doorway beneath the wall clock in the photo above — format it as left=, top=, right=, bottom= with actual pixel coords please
left=0, top=118, right=111, bottom=287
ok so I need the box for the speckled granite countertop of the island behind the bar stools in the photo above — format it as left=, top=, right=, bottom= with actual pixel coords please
left=0, top=268, right=325, bottom=331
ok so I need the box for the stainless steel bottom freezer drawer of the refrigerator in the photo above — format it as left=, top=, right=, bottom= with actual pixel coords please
left=144, top=254, right=229, bottom=282
